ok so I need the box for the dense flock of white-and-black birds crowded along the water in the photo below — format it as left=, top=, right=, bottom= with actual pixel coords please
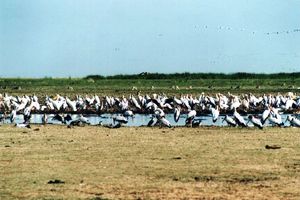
left=0, top=92, right=300, bottom=129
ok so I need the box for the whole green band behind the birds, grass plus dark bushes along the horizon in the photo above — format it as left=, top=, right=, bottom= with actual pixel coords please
left=0, top=73, right=300, bottom=95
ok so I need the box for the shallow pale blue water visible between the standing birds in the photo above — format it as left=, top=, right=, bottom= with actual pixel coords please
left=4, top=114, right=289, bottom=127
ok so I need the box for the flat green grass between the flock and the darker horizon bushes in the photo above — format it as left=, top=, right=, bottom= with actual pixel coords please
left=0, top=77, right=300, bottom=96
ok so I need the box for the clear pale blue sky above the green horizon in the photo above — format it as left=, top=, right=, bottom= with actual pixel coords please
left=0, top=0, right=300, bottom=77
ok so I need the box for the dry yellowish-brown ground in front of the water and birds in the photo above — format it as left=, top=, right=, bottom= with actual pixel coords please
left=0, top=125, right=300, bottom=199
